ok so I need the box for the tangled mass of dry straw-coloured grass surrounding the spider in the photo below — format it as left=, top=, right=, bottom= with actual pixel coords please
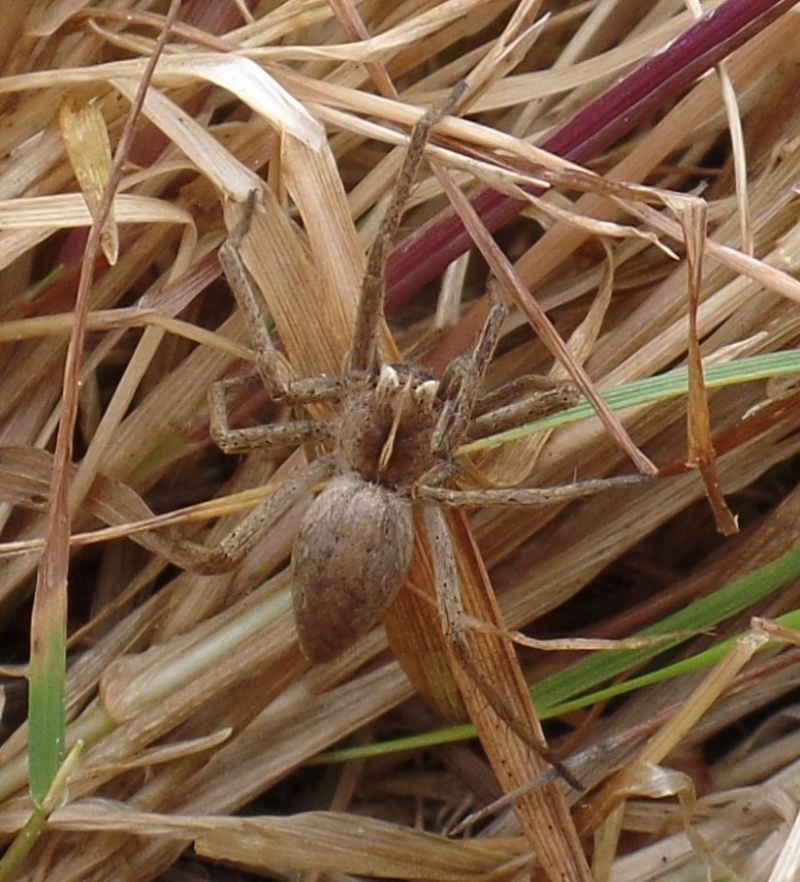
left=0, top=0, right=800, bottom=882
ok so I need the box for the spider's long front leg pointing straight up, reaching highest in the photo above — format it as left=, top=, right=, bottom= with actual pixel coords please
left=348, top=80, right=467, bottom=373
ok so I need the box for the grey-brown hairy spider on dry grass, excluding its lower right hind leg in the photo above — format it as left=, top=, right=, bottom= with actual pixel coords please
left=195, top=88, right=642, bottom=663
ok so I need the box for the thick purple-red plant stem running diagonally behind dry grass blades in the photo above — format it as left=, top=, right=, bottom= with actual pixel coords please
left=386, top=0, right=795, bottom=312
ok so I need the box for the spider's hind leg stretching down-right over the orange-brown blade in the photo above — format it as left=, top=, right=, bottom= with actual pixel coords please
left=422, top=505, right=584, bottom=791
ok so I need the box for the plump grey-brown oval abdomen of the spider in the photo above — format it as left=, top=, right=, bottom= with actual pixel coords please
left=292, top=475, right=414, bottom=662
